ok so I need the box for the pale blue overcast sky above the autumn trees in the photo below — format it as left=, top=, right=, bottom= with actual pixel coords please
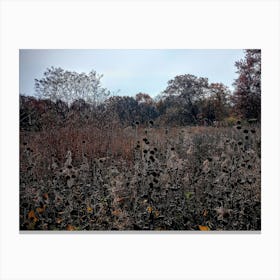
left=19, top=49, right=244, bottom=97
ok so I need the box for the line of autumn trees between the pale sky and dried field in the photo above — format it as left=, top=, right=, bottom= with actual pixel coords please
left=20, top=50, right=261, bottom=131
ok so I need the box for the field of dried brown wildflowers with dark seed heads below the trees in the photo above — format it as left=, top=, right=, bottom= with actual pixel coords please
left=20, top=122, right=261, bottom=231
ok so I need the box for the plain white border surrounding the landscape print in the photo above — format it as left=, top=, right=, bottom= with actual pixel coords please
left=0, top=0, right=280, bottom=280
